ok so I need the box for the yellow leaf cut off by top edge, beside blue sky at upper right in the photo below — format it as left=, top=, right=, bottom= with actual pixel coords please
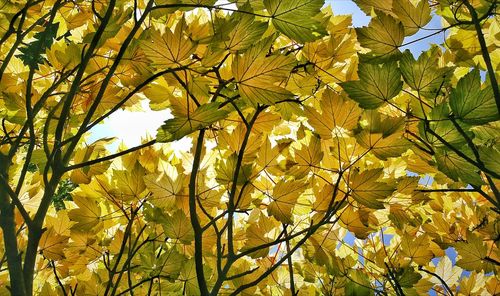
left=392, top=0, right=432, bottom=36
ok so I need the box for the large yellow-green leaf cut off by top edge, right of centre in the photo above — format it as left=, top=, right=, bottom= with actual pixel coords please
left=264, top=0, right=326, bottom=42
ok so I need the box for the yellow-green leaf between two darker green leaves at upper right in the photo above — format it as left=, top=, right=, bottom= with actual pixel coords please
left=400, top=47, right=452, bottom=99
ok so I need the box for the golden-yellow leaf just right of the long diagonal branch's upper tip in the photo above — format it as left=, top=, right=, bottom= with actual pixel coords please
left=349, top=169, right=395, bottom=209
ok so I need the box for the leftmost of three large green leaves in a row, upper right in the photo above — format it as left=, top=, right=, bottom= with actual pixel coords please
left=340, top=62, right=403, bottom=109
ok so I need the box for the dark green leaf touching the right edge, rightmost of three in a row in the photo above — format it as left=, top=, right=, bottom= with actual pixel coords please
left=450, top=69, right=500, bottom=124
